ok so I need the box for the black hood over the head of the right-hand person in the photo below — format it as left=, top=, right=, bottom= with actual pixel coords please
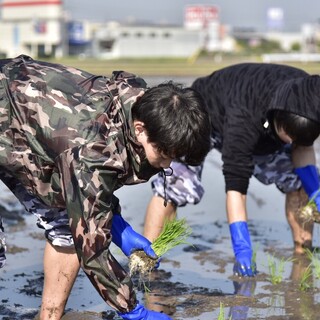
left=268, top=75, right=320, bottom=122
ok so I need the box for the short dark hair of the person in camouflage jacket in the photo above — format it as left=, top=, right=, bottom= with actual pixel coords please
left=132, top=81, right=211, bottom=165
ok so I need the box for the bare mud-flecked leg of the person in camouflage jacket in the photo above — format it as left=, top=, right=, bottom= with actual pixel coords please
left=40, top=242, right=80, bottom=320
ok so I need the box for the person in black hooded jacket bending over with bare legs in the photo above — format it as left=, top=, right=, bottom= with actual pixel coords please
left=144, top=63, right=320, bottom=276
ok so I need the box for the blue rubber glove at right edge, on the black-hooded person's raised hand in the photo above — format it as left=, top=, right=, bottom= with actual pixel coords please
left=294, top=165, right=320, bottom=212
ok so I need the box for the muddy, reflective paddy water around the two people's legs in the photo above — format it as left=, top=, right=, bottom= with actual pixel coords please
left=0, top=76, right=320, bottom=320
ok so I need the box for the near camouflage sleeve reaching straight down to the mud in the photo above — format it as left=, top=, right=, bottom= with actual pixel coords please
left=58, top=142, right=136, bottom=312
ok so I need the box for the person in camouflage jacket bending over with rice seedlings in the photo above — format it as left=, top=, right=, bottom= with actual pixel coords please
left=0, top=55, right=210, bottom=320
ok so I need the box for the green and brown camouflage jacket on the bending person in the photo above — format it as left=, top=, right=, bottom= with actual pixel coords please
left=0, top=56, right=156, bottom=310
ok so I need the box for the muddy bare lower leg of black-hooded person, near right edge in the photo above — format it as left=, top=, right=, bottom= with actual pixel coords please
left=286, top=189, right=313, bottom=254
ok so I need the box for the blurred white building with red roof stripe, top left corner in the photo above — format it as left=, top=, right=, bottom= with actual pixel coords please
left=0, top=0, right=65, bottom=57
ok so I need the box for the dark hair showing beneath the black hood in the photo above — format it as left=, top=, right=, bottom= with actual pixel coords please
left=272, top=110, right=320, bottom=146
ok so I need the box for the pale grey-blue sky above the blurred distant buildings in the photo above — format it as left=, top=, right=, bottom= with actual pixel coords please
left=63, top=0, right=320, bottom=32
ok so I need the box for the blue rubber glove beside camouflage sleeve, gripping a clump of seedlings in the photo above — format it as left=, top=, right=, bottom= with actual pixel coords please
left=111, top=214, right=158, bottom=259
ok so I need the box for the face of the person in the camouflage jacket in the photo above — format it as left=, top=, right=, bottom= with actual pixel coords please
left=135, top=121, right=173, bottom=168
